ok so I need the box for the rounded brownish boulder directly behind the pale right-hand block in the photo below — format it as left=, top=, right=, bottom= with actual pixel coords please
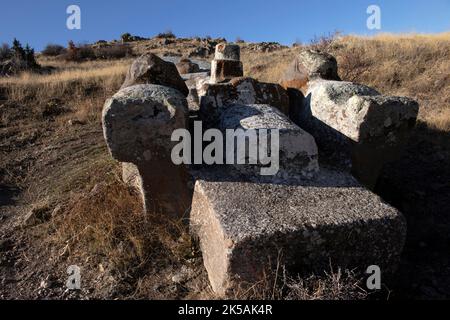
left=280, top=49, right=341, bottom=95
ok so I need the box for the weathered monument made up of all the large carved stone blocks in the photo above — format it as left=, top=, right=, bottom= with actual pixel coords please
left=103, top=44, right=418, bottom=295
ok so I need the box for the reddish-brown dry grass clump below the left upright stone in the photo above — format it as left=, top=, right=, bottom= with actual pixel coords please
left=49, top=168, right=197, bottom=298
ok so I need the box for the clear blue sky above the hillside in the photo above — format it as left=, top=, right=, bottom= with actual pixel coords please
left=0, top=0, right=450, bottom=50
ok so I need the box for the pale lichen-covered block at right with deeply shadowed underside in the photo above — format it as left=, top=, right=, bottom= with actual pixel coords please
left=294, top=80, right=419, bottom=188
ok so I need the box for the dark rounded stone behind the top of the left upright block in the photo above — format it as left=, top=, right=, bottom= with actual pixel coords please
left=122, top=53, right=189, bottom=97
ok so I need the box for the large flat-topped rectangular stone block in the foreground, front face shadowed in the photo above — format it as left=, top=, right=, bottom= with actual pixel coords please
left=191, top=170, right=406, bottom=295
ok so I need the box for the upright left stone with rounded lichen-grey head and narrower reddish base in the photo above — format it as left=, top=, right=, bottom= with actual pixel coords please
left=103, top=85, right=190, bottom=217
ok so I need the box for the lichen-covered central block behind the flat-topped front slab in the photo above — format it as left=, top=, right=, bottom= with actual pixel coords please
left=219, top=104, right=319, bottom=181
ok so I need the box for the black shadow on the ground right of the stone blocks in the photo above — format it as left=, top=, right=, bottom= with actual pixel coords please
left=376, top=123, right=450, bottom=299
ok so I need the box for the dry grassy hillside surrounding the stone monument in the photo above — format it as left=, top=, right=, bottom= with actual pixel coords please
left=0, top=33, right=450, bottom=299
